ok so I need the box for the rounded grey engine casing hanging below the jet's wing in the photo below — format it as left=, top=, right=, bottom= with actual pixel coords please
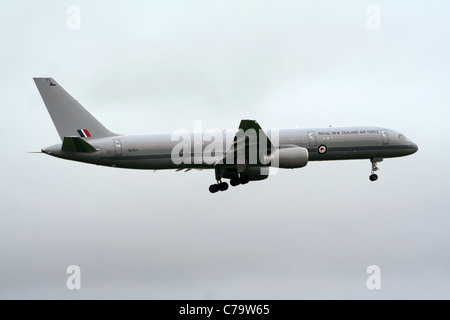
left=269, top=146, right=309, bottom=169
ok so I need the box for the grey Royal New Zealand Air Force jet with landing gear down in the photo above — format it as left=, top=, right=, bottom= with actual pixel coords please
left=33, top=78, right=418, bottom=193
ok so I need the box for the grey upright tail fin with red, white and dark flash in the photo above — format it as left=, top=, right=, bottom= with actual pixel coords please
left=33, top=78, right=117, bottom=140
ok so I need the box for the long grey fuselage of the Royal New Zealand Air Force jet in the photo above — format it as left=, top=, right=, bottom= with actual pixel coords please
left=42, top=127, right=418, bottom=169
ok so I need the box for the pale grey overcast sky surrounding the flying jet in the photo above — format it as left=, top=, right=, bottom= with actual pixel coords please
left=0, top=0, right=450, bottom=299
